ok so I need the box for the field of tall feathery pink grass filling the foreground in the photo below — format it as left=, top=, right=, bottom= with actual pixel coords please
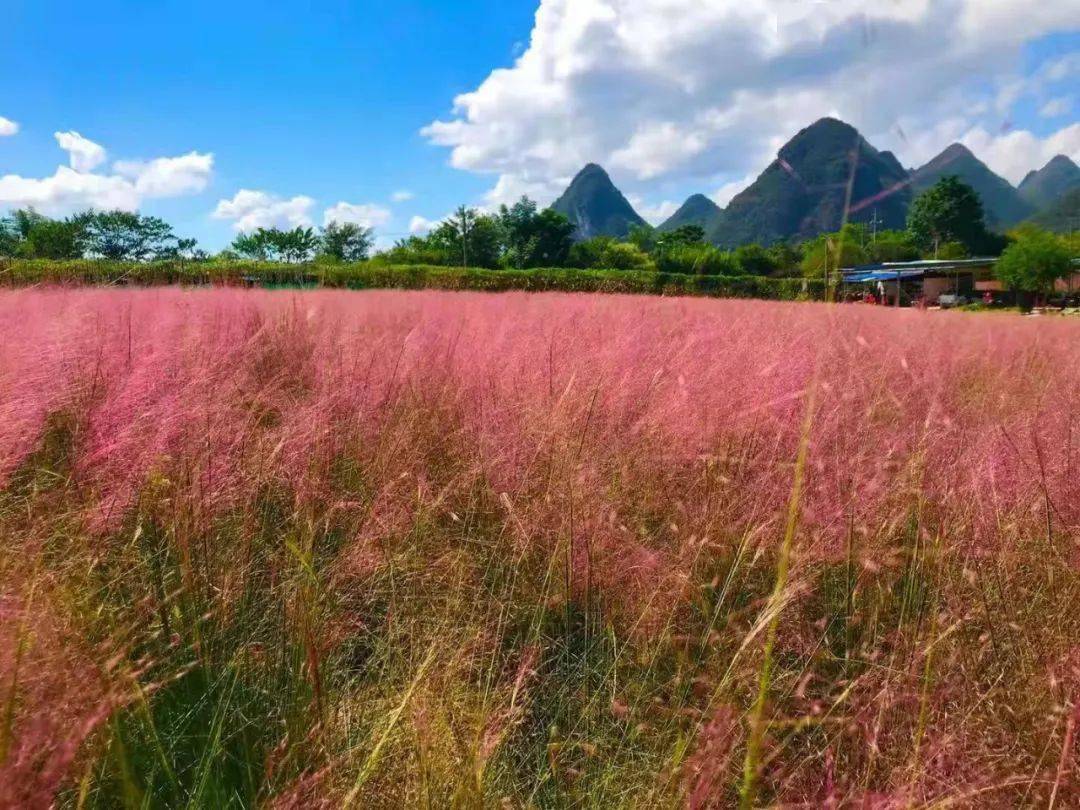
left=0, top=287, right=1080, bottom=808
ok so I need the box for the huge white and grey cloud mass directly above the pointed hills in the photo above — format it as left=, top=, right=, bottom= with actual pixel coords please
left=422, top=0, right=1080, bottom=202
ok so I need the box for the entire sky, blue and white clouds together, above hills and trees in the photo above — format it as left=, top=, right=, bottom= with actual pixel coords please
left=0, top=0, right=1080, bottom=248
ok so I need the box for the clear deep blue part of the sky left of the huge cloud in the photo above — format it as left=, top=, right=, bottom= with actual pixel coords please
left=0, top=0, right=536, bottom=246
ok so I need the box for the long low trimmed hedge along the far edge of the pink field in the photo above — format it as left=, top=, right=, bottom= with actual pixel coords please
left=0, top=259, right=824, bottom=300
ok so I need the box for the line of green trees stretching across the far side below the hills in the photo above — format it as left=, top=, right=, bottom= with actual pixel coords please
left=0, top=177, right=1080, bottom=292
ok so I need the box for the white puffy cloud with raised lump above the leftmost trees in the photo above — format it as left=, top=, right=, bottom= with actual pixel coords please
left=0, top=132, right=214, bottom=216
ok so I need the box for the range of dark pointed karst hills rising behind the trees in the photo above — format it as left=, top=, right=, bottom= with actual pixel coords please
left=552, top=118, right=1080, bottom=249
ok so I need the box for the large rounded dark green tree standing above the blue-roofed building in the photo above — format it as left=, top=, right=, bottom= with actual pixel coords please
left=907, top=175, right=988, bottom=258
